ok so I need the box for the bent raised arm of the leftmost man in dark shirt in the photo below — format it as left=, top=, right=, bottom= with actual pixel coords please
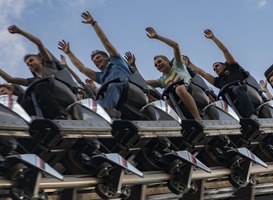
left=8, top=25, right=53, bottom=62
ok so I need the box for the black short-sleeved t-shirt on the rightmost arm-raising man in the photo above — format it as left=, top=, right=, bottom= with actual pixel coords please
left=214, top=63, right=247, bottom=89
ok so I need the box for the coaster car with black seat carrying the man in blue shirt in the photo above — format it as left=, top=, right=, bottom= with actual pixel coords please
left=91, top=73, right=212, bottom=194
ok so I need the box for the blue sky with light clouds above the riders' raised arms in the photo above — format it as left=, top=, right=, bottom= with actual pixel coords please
left=0, top=0, right=273, bottom=92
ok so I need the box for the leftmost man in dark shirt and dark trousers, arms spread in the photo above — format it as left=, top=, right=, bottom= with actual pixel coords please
left=0, top=25, right=76, bottom=119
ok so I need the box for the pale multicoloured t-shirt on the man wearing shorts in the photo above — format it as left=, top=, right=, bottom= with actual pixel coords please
left=157, top=59, right=191, bottom=88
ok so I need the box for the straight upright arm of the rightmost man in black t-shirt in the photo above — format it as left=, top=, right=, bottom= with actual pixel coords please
left=204, top=29, right=236, bottom=64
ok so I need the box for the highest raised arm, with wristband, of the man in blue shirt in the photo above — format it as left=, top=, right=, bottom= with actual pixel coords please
left=81, top=11, right=119, bottom=56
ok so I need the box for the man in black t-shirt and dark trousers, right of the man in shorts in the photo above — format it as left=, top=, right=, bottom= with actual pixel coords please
left=184, top=29, right=258, bottom=120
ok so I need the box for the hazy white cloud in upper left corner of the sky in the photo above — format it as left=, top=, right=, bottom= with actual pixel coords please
left=0, top=0, right=107, bottom=82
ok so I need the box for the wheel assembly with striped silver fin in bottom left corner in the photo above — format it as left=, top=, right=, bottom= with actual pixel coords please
left=0, top=154, right=63, bottom=200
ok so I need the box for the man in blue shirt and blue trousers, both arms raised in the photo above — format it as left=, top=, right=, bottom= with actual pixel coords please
left=58, top=11, right=132, bottom=115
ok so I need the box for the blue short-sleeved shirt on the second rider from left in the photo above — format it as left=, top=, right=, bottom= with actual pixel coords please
left=96, top=55, right=132, bottom=84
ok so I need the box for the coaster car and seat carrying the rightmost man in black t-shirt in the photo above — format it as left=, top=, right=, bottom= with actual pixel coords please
left=219, top=75, right=273, bottom=161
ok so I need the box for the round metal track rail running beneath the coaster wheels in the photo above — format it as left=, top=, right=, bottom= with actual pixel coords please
left=0, top=163, right=273, bottom=189
